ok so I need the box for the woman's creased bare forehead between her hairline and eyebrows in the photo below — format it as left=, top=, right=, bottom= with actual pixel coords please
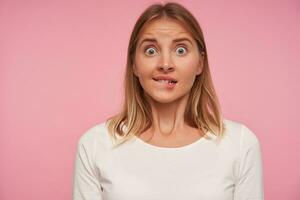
left=139, top=18, right=192, bottom=39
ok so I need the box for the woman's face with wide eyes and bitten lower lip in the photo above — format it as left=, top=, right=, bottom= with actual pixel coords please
left=133, top=18, right=203, bottom=103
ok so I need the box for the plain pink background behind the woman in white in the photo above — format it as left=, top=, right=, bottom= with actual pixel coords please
left=0, top=0, right=300, bottom=200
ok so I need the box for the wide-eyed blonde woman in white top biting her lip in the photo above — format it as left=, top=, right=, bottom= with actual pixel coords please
left=73, top=2, right=263, bottom=200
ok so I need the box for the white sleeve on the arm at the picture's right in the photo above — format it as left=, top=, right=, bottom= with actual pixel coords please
left=234, top=125, right=264, bottom=200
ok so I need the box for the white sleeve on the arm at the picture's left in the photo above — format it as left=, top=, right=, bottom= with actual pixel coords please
left=72, top=134, right=102, bottom=200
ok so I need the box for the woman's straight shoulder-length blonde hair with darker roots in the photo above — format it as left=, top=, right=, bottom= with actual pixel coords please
left=106, top=2, right=225, bottom=146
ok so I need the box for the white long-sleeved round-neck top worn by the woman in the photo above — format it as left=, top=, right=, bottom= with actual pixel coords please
left=72, top=119, right=264, bottom=200
